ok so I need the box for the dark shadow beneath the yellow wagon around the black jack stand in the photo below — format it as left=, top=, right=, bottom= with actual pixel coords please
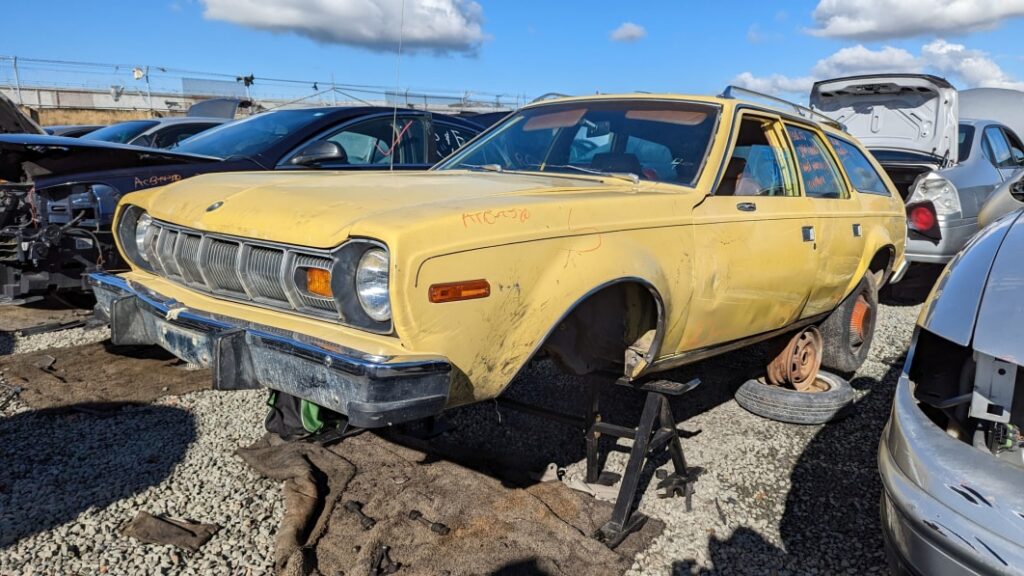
left=407, top=336, right=777, bottom=487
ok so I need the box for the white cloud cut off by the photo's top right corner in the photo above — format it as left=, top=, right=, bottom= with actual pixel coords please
left=809, top=0, right=1024, bottom=40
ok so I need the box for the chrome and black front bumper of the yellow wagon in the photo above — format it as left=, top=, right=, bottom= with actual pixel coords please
left=89, top=273, right=452, bottom=427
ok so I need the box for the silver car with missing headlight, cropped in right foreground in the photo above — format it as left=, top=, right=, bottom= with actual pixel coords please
left=879, top=207, right=1024, bottom=575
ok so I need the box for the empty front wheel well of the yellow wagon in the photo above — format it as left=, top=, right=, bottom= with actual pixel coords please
left=542, top=282, right=659, bottom=375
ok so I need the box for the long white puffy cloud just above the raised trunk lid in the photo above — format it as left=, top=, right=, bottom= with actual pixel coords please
left=732, top=39, right=1024, bottom=96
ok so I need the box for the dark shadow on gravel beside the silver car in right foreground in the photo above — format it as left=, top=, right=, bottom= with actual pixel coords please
left=671, top=359, right=902, bottom=576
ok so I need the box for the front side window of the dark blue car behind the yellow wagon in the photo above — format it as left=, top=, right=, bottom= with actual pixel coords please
left=325, top=116, right=427, bottom=166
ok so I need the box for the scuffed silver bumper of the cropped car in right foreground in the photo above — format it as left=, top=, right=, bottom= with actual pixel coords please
left=879, top=362, right=1024, bottom=576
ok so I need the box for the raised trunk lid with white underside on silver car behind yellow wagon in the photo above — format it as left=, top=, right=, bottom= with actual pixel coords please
left=810, top=74, right=958, bottom=161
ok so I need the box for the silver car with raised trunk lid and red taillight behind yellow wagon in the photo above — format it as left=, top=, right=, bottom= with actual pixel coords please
left=810, top=74, right=1024, bottom=270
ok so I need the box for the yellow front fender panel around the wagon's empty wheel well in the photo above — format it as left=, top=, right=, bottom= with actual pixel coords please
left=394, top=229, right=692, bottom=405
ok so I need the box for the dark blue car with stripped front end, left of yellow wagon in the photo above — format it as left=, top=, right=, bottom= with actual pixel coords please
left=0, top=96, right=482, bottom=303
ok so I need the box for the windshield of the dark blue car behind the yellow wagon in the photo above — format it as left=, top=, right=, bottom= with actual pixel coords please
left=174, top=109, right=327, bottom=159
